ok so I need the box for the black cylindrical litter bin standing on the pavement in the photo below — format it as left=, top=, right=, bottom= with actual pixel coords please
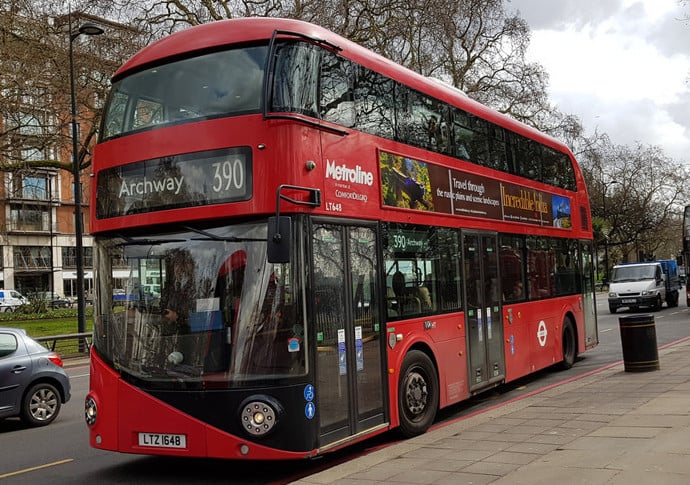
left=618, top=315, right=659, bottom=372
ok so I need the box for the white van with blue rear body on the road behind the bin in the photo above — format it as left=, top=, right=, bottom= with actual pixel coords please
left=608, top=260, right=681, bottom=313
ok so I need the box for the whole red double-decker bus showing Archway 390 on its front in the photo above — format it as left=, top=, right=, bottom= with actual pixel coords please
left=86, top=18, right=597, bottom=459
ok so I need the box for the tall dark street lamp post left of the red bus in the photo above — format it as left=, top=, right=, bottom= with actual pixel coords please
left=68, top=17, right=103, bottom=333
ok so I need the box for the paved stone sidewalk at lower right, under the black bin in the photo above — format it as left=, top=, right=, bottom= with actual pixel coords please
left=295, top=340, right=690, bottom=485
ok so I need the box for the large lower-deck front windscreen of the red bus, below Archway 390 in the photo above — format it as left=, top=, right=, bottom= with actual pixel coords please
left=94, top=222, right=306, bottom=388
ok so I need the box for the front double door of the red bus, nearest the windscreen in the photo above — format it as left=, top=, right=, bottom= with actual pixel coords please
left=311, top=221, right=387, bottom=448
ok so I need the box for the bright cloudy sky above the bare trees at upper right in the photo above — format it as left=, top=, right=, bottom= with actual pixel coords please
left=506, top=0, right=690, bottom=164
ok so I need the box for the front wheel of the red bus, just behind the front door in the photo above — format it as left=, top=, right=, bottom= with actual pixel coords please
left=398, top=350, right=439, bottom=438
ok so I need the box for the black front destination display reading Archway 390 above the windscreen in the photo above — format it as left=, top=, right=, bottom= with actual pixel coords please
left=96, top=147, right=252, bottom=219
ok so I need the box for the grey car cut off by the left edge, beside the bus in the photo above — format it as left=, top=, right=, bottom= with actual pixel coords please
left=0, top=327, right=71, bottom=426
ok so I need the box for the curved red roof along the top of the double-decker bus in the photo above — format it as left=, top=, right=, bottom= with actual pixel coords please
left=113, top=17, right=571, bottom=155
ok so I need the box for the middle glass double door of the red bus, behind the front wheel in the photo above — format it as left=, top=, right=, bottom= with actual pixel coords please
left=462, top=232, right=505, bottom=392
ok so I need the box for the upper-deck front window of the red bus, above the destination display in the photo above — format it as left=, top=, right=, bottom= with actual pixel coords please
left=101, top=46, right=268, bottom=141
